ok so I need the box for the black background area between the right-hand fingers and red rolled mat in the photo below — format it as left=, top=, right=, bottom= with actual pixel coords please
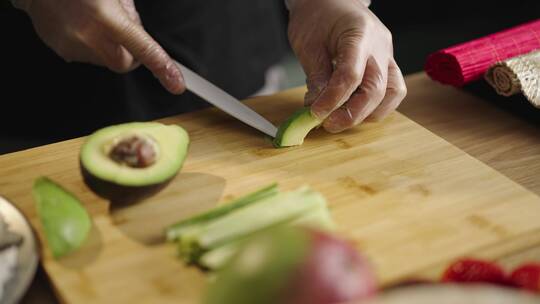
left=371, top=0, right=540, bottom=74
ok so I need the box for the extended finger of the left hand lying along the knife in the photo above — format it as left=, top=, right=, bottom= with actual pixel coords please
left=105, top=7, right=185, bottom=94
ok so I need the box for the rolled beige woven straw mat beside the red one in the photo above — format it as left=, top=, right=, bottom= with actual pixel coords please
left=485, top=50, right=540, bottom=108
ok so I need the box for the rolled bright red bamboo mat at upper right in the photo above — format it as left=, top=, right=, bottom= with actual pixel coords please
left=425, top=19, right=540, bottom=87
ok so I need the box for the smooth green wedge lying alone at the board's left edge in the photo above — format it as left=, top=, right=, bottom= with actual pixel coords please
left=32, top=177, right=92, bottom=258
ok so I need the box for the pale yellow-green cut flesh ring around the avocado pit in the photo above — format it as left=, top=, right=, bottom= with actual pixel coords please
left=80, top=122, right=189, bottom=187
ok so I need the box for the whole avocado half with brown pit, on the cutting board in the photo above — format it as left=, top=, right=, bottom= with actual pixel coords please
left=80, top=122, right=189, bottom=202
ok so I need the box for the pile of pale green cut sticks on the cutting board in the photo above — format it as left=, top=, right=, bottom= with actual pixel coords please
left=166, top=185, right=334, bottom=269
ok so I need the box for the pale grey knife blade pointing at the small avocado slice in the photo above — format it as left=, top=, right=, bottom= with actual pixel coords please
left=177, top=62, right=277, bottom=137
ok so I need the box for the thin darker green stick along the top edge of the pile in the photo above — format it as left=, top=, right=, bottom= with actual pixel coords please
left=166, top=183, right=278, bottom=241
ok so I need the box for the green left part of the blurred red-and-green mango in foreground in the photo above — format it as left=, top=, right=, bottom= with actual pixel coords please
left=203, top=227, right=311, bottom=304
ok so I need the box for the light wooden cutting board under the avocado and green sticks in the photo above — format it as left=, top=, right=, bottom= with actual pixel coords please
left=0, top=89, right=540, bottom=303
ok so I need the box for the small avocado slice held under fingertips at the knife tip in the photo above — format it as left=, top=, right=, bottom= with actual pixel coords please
left=274, top=108, right=321, bottom=148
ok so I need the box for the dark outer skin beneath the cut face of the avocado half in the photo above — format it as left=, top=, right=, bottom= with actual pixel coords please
left=79, top=160, right=174, bottom=205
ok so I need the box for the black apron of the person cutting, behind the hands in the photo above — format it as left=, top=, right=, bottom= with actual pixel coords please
left=0, top=0, right=287, bottom=153
